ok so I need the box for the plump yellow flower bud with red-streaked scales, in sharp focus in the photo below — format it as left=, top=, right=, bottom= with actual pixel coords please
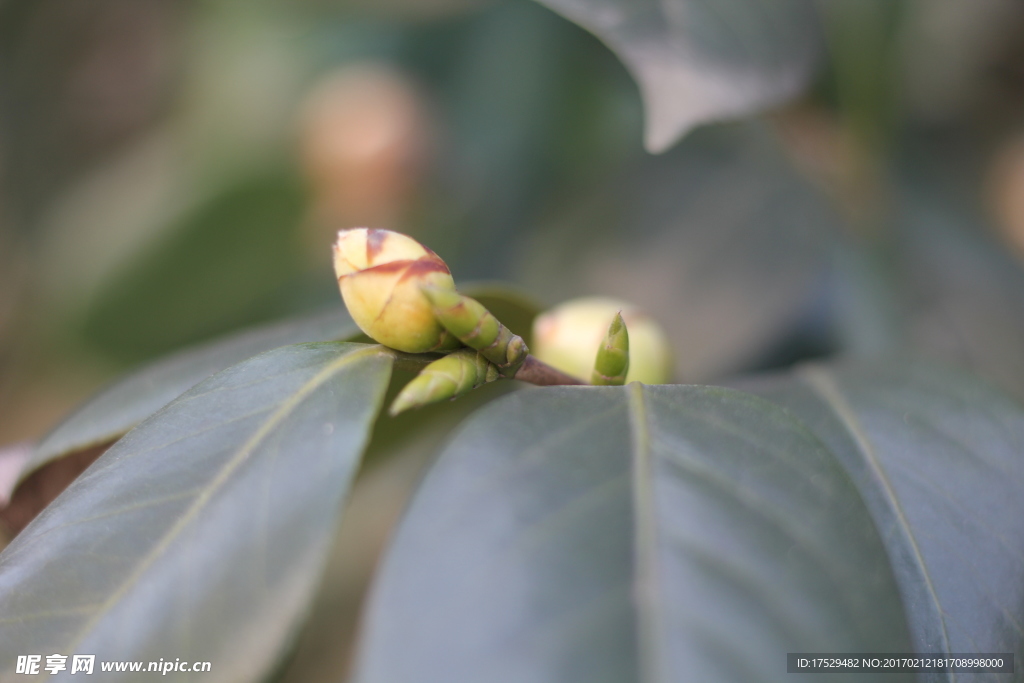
left=334, top=227, right=460, bottom=353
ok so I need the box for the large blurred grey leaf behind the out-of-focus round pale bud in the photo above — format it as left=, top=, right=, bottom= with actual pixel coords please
left=520, top=124, right=841, bottom=382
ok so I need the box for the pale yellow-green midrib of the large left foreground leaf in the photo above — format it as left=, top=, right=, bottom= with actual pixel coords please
left=47, top=346, right=381, bottom=678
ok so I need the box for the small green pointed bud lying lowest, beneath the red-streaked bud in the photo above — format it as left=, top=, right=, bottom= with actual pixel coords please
left=388, top=348, right=500, bottom=417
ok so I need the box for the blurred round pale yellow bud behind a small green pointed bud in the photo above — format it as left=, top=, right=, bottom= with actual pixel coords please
left=531, top=297, right=672, bottom=384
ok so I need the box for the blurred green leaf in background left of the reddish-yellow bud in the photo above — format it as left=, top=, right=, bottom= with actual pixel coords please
left=83, top=167, right=305, bottom=361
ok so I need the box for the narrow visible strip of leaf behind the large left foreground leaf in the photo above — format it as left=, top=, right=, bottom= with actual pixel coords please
left=19, top=309, right=358, bottom=483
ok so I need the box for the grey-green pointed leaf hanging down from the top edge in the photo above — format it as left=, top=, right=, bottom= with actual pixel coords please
left=540, top=0, right=821, bottom=152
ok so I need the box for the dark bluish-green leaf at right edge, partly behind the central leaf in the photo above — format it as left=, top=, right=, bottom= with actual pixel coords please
left=749, top=361, right=1024, bottom=681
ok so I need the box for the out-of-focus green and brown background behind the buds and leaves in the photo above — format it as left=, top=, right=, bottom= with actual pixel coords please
left=0, top=0, right=1024, bottom=443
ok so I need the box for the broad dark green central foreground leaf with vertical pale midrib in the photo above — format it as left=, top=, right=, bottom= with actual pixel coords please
left=358, top=384, right=908, bottom=683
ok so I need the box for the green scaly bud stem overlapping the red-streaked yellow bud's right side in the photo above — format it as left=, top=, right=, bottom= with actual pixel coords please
left=421, top=285, right=529, bottom=377
